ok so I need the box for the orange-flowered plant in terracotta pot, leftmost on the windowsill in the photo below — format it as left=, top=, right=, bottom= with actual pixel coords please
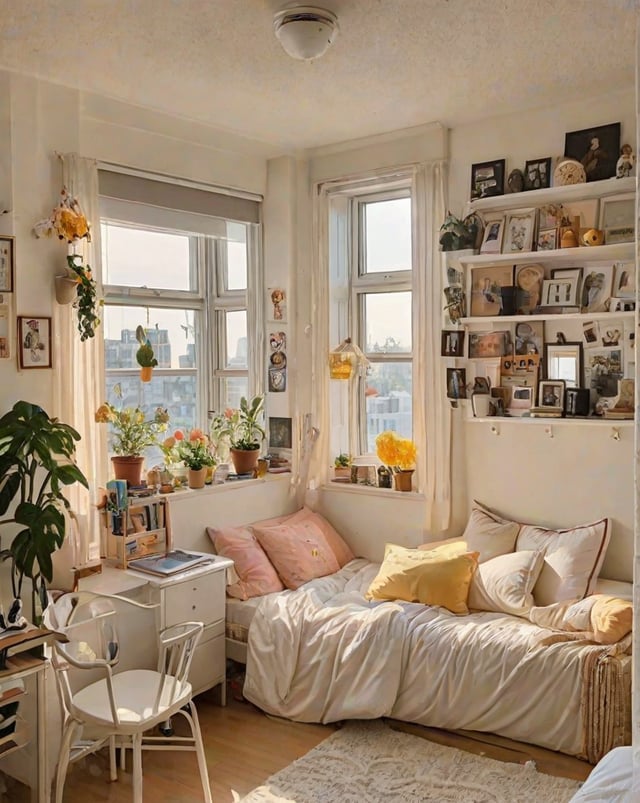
left=95, top=384, right=169, bottom=486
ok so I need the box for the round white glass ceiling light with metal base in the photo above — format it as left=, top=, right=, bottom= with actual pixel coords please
left=273, top=6, right=340, bottom=61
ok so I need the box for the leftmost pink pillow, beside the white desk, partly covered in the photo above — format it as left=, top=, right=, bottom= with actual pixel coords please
left=207, top=527, right=284, bottom=599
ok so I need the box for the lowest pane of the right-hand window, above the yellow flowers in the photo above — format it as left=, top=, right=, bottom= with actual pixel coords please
left=365, top=362, right=413, bottom=452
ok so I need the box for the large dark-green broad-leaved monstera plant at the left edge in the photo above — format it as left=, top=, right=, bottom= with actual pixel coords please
left=0, top=401, right=89, bottom=623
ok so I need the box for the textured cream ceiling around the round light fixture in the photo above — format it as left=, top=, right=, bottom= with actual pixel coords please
left=0, top=0, right=636, bottom=152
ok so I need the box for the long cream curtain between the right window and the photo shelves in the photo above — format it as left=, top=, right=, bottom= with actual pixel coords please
left=412, top=162, right=451, bottom=533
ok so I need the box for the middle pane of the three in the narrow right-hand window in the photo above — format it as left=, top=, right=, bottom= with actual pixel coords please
left=364, top=292, right=411, bottom=354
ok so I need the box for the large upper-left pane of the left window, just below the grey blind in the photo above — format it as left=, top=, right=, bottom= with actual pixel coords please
left=101, top=223, right=192, bottom=291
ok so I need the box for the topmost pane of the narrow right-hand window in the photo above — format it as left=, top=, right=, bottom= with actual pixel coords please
left=363, top=198, right=411, bottom=273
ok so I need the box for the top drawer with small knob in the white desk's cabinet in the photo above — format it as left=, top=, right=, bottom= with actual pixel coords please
left=164, top=572, right=225, bottom=627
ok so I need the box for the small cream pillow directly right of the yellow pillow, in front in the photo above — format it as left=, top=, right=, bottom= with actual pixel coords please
left=468, top=549, right=544, bottom=616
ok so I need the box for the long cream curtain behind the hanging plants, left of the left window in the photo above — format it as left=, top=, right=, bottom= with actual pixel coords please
left=53, top=154, right=108, bottom=564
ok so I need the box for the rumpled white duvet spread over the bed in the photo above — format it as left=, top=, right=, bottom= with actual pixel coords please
left=244, top=559, right=632, bottom=755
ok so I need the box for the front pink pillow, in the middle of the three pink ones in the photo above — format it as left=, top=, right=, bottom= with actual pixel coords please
left=253, top=521, right=340, bottom=589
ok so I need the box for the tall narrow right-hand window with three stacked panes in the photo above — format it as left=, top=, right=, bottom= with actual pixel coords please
left=330, top=181, right=413, bottom=454
